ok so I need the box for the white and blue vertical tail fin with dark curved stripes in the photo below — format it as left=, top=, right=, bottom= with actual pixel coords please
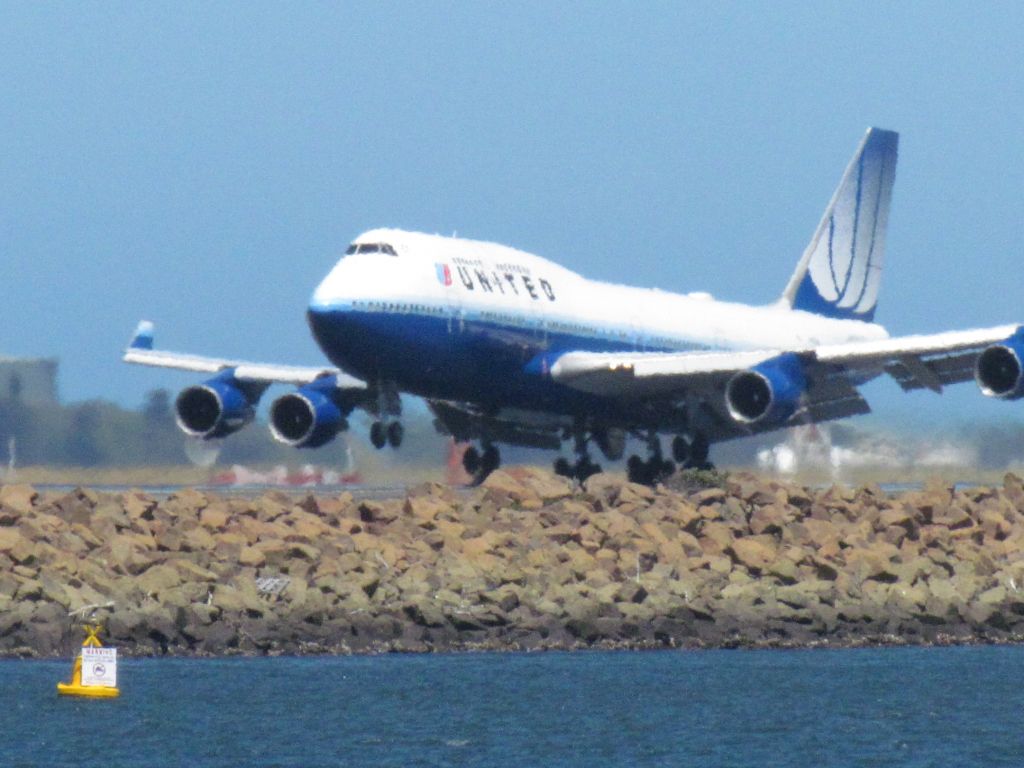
left=782, top=128, right=899, bottom=323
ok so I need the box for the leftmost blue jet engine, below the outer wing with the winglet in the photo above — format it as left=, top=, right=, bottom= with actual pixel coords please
left=174, top=371, right=262, bottom=439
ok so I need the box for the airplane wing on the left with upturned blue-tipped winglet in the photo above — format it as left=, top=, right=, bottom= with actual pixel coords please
left=123, top=321, right=368, bottom=389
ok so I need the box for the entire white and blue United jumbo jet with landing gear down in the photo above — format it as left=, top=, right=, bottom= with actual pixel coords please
left=124, top=128, right=1024, bottom=483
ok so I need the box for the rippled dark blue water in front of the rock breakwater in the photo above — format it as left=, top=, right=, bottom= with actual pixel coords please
left=0, top=646, right=1024, bottom=768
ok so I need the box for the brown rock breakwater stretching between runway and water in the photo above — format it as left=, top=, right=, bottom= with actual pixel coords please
left=0, top=468, right=1024, bottom=656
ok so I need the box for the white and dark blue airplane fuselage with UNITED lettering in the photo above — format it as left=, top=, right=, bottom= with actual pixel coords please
left=308, top=229, right=887, bottom=423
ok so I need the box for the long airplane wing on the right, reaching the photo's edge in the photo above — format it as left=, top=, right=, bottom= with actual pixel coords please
left=549, top=326, right=1024, bottom=439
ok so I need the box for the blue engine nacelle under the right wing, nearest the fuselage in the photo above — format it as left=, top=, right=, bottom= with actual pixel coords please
left=725, top=353, right=807, bottom=424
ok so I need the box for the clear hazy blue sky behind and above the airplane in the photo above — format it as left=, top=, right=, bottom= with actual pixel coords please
left=0, top=2, right=1024, bottom=434
